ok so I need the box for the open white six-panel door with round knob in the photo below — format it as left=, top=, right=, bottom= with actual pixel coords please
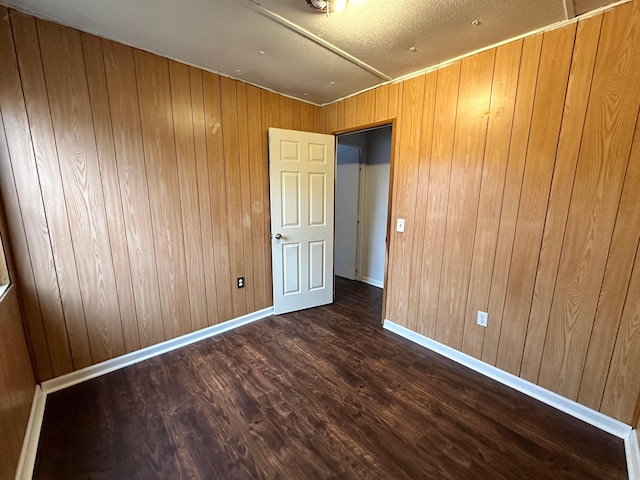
left=269, top=128, right=335, bottom=314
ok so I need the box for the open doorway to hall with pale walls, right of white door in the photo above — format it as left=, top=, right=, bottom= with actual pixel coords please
left=334, top=125, right=392, bottom=316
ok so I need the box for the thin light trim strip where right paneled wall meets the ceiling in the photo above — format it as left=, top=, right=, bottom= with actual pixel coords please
left=320, top=0, right=640, bottom=107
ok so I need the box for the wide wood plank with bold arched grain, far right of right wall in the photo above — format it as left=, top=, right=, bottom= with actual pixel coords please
left=539, top=2, right=640, bottom=400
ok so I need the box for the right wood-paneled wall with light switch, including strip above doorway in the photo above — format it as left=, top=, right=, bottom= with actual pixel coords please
left=323, top=0, right=640, bottom=425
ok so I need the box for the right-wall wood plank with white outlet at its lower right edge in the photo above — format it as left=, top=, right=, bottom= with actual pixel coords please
left=462, top=41, right=522, bottom=358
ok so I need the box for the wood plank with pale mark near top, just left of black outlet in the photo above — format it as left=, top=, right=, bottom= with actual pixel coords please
left=202, top=72, right=233, bottom=322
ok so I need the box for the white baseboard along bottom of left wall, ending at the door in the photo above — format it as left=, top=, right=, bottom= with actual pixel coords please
left=42, top=307, right=273, bottom=394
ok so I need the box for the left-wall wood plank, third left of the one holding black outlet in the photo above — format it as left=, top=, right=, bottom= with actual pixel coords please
left=169, top=61, right=209, bottom=331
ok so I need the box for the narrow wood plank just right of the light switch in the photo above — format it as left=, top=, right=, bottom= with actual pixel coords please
left=406, top=72, right=438, bottom=330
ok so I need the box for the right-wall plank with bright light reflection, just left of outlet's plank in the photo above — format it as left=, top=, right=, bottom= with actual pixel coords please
left=435, top=50, right=496, bottom=350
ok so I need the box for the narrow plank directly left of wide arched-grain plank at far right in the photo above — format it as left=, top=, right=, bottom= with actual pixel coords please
left=520, top=15, right=602, bottom=383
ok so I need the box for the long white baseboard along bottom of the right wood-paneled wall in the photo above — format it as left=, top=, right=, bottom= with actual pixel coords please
left=384, top=320, right=631, bottom=439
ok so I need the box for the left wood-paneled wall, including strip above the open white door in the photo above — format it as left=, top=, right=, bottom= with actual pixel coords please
left=0, top=8, right=323, bottom=380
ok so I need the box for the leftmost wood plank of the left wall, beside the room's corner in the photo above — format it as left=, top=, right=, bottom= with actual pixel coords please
left=0, top=9, right=73, bottom=378
